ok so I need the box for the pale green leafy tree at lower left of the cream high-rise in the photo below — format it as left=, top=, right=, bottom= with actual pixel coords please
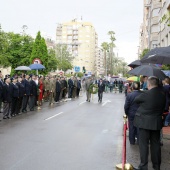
left=56, top=44, right=73, bottom=71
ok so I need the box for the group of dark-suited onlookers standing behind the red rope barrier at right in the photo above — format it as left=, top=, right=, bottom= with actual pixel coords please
left=124, top=77, right=170, bottom=170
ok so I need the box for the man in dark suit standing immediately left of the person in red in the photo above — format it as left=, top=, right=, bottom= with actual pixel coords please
left=29, top=75, right=37, bottom=111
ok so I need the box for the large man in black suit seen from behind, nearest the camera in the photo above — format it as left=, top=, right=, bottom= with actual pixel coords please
left=134, top=77, right=166, bottom=170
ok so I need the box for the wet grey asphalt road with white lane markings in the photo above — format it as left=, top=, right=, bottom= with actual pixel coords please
left=0, top=93, right=170, bottom=170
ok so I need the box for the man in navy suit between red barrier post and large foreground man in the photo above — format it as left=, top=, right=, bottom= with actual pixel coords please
left=124, top=82, right=141, bottom=145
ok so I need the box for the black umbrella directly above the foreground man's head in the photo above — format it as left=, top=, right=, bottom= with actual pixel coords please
left=128, top=65, right=166, bottom=80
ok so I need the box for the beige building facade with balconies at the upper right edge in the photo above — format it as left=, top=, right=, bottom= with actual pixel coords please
left=138, top=0, right=170, bottom=55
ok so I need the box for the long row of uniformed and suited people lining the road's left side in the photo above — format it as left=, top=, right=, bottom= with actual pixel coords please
left=0, top=72, right=81, bottom=119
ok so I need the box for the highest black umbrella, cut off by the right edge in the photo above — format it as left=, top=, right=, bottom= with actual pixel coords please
left=141, top=46, right=170, bottom=64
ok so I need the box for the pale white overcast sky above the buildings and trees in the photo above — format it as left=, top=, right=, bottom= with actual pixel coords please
left=0, top=0, right=143, bottom=63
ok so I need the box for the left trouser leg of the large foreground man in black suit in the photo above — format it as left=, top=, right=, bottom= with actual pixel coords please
left=139, top=128, right=150, bottom=170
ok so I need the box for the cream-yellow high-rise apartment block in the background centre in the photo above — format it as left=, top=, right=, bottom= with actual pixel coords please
left=56, top=19, right=98, bottom=74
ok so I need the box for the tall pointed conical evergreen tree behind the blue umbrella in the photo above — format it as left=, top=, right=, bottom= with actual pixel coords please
left=30, top=31, right=49, bottom=74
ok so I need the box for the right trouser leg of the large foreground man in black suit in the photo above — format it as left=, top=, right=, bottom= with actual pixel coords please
left=150, top=130, right=161, bottom=170
